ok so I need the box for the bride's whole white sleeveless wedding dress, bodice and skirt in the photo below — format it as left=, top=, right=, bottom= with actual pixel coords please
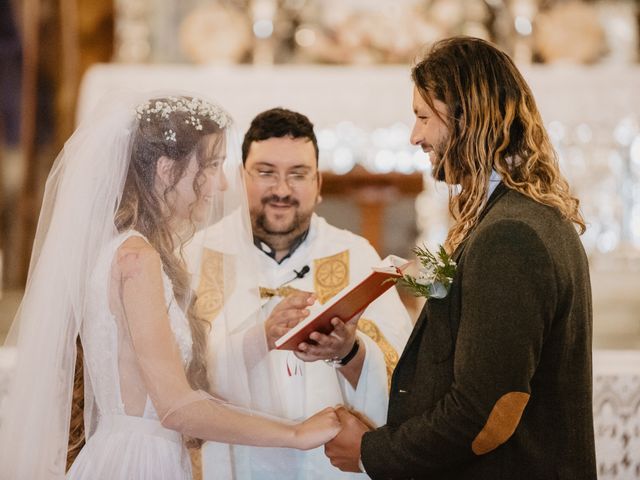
left=67, top=231, right=192, bottom=480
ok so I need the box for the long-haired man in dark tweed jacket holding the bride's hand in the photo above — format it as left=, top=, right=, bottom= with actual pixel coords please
left=325, top=37, right=596, bottom=479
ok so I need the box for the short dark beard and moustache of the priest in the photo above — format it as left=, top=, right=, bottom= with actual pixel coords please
left=250, top=195, right=313, bottom=251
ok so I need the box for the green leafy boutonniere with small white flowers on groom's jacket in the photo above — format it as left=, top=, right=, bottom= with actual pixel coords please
left=398, top=245, right=456, bottom=299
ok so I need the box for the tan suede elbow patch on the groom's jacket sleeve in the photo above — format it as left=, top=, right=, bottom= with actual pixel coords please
left=471, top=392, right=529, bottom=455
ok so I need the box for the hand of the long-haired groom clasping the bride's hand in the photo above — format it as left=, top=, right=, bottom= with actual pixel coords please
left=324, top=407, right=371, bottom=472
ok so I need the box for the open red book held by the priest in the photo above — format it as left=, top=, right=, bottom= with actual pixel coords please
left=275, top=255, right=409, bottom=350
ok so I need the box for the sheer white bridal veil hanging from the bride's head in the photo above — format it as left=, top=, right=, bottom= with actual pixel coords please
left=0, top=92, right=279, bottom=480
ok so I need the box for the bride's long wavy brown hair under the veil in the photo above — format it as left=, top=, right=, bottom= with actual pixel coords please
left=67, top=97, right=229, bottom=466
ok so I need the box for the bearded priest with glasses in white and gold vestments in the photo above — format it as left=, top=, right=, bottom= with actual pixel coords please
left=192, top=108, right=411, bottom=480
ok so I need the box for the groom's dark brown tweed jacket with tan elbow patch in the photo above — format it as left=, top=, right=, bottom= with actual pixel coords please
left=361, top=184, right=596, bottom=480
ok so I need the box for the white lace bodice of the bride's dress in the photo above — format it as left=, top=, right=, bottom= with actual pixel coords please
left=81, top=231, right=192, bottom=419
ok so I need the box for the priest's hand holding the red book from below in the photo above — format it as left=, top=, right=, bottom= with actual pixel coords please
left=294, top=312, right=362, bottom=362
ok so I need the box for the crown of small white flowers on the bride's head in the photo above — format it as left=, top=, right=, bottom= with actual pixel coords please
left=136, top=97, right=231, bottom=142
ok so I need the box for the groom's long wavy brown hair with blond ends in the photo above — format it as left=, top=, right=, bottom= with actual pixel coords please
left=411, top=37, right=586, bottom=252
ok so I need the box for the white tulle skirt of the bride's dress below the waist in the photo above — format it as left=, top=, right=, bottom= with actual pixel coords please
left=67, top=415, right=192, bottom=480
